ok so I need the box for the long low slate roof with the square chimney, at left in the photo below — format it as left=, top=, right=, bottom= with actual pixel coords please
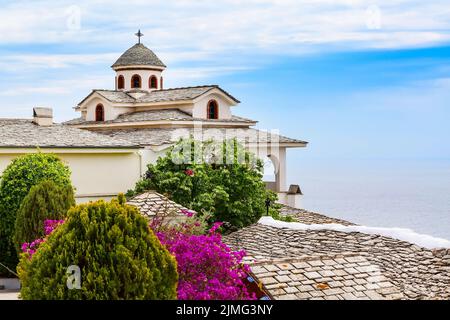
left=0, top=119, right=139, bottom=148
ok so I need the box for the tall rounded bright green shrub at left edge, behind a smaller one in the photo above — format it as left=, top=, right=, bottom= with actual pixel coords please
left=0, top=152, right=71, bottom=274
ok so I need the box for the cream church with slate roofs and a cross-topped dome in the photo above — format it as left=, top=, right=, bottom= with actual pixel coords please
left=0, top=31, right=307, bottom=207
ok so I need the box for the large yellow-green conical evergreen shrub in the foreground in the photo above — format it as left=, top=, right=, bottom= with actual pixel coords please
left=18, top=200, right=178, bottom=300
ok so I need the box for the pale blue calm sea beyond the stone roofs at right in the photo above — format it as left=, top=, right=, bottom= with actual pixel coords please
left=288, top=159, right=450, bottom=240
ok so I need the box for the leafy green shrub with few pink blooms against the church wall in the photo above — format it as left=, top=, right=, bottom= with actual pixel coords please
left=127, top=139, right=277, bottom=229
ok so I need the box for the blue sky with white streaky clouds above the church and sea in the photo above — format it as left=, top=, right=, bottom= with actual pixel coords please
left=0, top=0, right=450, bottom=182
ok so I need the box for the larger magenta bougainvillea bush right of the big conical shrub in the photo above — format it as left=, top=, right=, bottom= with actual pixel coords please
left=153, top=215, right=256, bottom=300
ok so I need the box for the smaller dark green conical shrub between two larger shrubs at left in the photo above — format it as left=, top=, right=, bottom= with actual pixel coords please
left=14, top=181, right=75, bottom=252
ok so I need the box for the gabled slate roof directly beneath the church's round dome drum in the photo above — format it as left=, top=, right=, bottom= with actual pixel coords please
left=78, top=85, right=239, bottom=105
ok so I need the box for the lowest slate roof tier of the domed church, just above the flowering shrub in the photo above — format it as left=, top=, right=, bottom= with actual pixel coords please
left=98, top=128, right=307, bottom=146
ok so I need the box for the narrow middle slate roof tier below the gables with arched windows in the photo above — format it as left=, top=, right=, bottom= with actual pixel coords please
left=64, top=109, right=256, bottom=125
